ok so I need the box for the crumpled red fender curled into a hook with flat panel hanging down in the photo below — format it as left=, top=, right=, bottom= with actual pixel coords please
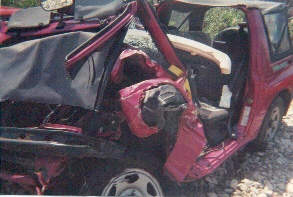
left=120, top=78, right=206, bottom=182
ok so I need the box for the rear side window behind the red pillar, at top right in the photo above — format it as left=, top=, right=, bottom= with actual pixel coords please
left=264, top=12, right=290, bottom=55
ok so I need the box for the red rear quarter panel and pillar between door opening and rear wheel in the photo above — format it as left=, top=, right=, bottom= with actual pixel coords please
left=246, top=9, right=293, bottom=138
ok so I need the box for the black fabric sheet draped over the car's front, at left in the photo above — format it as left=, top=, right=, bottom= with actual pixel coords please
left=0, top=32, right=110, bottom=110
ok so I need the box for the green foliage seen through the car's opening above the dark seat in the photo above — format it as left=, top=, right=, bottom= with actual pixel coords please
left=203, top=7, right=245, bottom=37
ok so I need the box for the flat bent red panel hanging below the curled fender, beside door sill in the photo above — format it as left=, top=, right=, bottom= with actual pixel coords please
left=164, top=104, right=206, bottom=182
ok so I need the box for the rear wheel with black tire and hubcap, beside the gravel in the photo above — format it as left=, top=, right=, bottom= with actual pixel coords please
left=251, top=97, right=285, bottom=151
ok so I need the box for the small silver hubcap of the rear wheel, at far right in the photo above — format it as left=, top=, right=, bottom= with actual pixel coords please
left=265, top=107, right=281, bottom=142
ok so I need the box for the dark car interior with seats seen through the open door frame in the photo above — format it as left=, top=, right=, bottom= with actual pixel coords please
left=159, top=3, right=249, bottom=146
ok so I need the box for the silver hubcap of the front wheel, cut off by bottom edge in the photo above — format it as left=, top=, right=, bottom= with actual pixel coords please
left=102, top=169, right=163, bottom=196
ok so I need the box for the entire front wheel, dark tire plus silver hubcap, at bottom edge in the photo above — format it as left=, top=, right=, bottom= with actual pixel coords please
left=83, top=152, right=164, bottom=196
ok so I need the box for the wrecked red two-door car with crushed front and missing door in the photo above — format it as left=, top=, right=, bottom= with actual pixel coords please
left=0, top=0, right=293, bottom=196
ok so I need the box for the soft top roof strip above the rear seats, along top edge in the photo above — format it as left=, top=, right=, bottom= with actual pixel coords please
left=174, top=0, right=286, bottom=14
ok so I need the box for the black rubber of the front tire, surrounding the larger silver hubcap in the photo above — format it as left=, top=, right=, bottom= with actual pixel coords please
left=82, top=151, right=166, bottom=196
